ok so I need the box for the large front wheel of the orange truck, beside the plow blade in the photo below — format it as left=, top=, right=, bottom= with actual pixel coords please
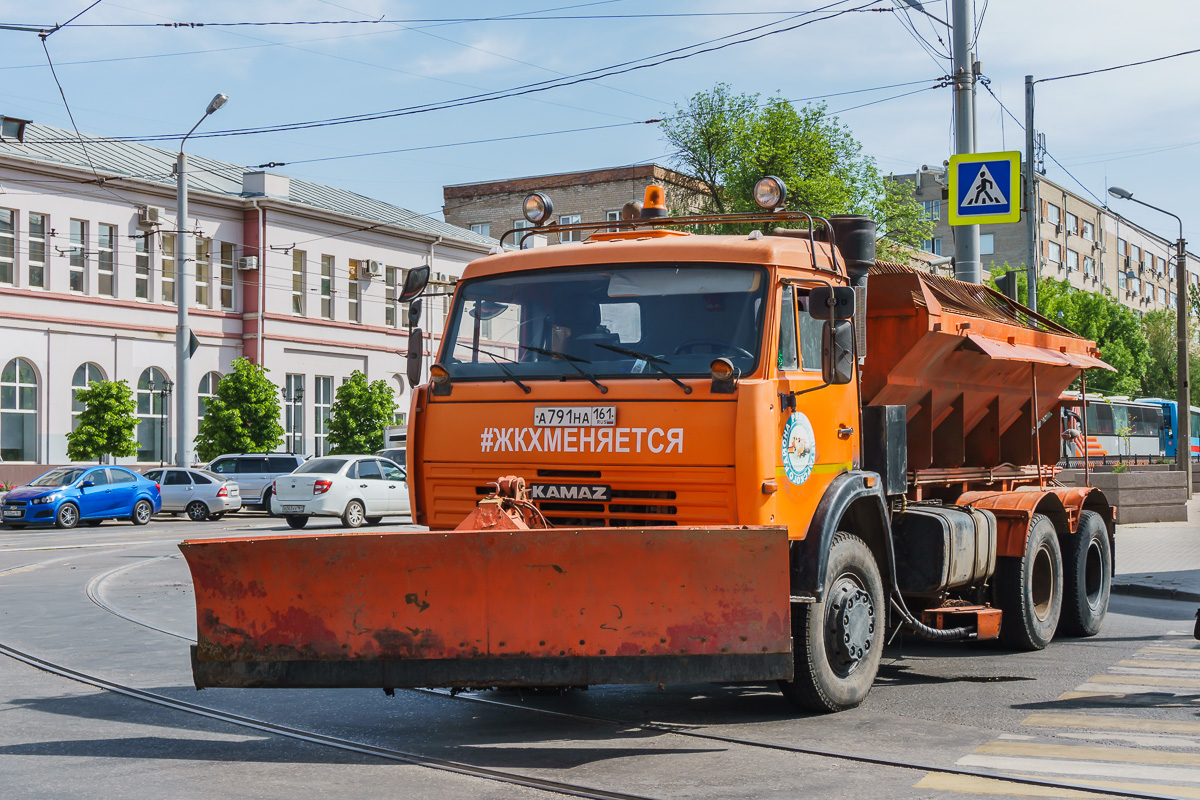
left=779, top=531, right=887, bottom=712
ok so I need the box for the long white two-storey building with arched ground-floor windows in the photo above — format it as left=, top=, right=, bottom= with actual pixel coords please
left=0, top=118, right=496, bottom=477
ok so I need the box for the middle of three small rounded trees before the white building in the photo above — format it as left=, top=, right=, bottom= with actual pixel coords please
left=196, top=359, right=283, bottom=461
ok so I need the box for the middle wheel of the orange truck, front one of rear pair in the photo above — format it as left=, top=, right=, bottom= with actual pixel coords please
left=995, top=513, right=1062, bottom=650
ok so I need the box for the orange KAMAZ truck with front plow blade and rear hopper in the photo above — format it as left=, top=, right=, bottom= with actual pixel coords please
left=181, top=179, right=1114, bottom=711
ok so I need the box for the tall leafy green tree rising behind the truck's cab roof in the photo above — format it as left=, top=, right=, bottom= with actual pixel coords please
left=661, top=84, right=932, bottom=258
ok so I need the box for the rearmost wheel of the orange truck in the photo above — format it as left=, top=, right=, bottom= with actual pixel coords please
left=1058, top=511, right=1112, bottom=636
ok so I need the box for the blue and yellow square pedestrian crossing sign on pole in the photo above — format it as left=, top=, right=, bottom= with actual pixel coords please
left=949, top=150, right=1021, bottom=225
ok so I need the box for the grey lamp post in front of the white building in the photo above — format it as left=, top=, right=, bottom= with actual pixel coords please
left=175, top=95, right=229, bottom=467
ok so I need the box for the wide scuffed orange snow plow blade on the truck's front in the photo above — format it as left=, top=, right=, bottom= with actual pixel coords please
left=180, top=527, right=792, bottom=688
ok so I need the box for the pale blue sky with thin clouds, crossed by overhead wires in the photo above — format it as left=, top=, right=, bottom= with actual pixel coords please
left=0, top=0, right=1200, bottom=244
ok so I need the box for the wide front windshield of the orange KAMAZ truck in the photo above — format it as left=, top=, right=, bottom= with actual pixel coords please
left=442, top=264, right=767, bottom=380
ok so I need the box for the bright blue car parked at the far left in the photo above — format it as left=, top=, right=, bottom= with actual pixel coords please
left=0, top=467, right=162, bottom=528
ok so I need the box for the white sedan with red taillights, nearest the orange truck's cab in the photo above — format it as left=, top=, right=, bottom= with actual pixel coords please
left=271, top=456, right=409, bottom=528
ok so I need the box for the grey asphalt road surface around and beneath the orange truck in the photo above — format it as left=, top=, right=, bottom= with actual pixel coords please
left=0, top=512, right=1200, bottom=800
